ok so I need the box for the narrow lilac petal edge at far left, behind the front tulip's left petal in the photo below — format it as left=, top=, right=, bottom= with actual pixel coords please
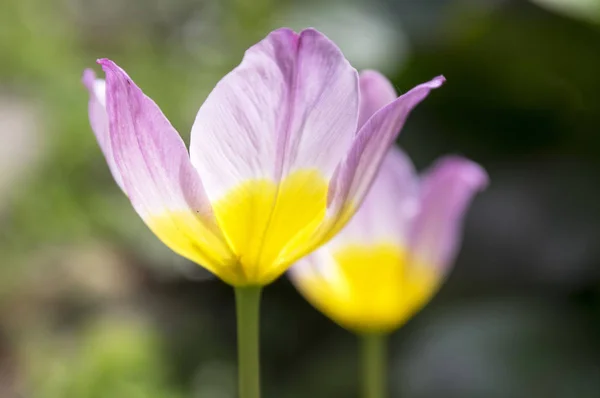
left=82, top=69, right=125, bottom=191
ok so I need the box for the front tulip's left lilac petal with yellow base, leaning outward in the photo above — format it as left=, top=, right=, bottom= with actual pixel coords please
left=98, top=59, right=238, bottom=283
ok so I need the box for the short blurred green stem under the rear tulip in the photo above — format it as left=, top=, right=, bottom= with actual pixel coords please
left=360, top=334, right=387, bottom=398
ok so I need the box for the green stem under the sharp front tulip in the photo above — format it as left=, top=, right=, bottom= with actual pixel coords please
left=235, top=286, right=262, bottom=398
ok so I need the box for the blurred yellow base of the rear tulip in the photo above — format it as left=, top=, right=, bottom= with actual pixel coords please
left=298, top=244, right=439, bottom=333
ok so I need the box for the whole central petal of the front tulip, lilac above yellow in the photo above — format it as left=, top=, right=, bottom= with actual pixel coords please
left=185, top=29, right=358, bottom=283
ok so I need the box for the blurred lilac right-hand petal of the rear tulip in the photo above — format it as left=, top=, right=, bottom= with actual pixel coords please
left=409, top=157, right=488, bottom=272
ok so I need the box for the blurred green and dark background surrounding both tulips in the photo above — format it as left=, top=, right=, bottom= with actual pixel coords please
left=0, top=0, right=600, bottom=398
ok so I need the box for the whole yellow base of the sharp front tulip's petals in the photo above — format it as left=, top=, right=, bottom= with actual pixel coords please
left=148, top=170, right=328, bottom=286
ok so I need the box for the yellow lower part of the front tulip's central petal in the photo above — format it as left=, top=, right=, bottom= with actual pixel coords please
left=213, top=170, right=327, bottom=285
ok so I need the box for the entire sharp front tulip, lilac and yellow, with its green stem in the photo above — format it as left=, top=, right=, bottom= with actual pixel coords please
left=83, top=29, right=444, bottom=398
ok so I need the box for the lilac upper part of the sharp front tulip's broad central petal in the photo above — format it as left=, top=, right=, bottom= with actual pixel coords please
left=190, top=29, right=358, bottom=200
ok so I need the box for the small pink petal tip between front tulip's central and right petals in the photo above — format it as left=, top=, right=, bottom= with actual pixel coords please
left=358, top=70, right=398, bottom=128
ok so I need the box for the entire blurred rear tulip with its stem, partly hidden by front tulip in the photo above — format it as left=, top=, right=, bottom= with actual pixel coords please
left=290, top=72, right=488, bottom=398
